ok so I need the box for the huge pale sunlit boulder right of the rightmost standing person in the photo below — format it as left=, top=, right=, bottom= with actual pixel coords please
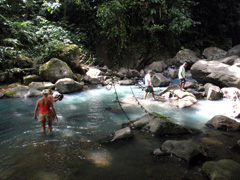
left=191, top=60, right=240, bottom=88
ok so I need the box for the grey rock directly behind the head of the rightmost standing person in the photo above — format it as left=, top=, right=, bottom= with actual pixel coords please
left=172, top=49, right=199, bottom=67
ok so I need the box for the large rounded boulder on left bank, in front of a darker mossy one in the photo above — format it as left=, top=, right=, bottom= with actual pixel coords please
left=39, top=58, right=74, bottom=83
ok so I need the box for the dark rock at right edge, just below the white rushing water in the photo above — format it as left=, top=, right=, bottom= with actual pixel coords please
left=206, top=115, right=240, bottom=131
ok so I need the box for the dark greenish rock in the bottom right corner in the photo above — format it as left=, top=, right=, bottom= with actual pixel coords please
left=202, top=159, right=240, bottom=180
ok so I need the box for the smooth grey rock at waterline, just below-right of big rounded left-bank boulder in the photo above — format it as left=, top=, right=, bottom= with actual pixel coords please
left=55, top=78, right=84, bottom=94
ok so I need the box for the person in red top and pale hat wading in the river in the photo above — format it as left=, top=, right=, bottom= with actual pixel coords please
left=34, top=89, right=58, bottom=134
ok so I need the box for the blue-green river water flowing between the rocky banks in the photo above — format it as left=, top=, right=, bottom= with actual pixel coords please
left=0, top=86, right=234, bottom=180
